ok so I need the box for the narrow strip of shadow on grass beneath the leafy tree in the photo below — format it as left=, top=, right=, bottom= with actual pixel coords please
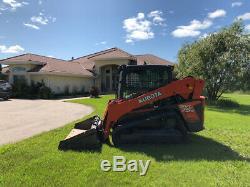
left=207, top=105, right=250, bottom=115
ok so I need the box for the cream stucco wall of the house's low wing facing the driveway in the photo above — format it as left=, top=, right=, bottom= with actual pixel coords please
left=31, top=75, right=93, bottom=94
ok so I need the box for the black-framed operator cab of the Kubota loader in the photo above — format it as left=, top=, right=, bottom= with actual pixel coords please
left=117, top=65, right=174, bottom=99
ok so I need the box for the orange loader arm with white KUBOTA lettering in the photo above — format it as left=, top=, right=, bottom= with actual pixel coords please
left=104, top=78, right=204, bottom=138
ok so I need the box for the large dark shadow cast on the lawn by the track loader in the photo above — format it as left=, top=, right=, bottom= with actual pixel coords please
left=116, top=134, right=250, bottom=162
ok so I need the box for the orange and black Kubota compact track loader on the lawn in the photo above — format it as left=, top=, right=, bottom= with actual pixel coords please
left=59, top=65, right=205, bottom=150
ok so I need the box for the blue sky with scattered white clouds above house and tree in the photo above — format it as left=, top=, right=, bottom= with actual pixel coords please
left=0, top=0, right=250, bottom=62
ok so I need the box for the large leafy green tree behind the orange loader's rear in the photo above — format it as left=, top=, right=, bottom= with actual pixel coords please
left=176, top=21, right=250, bottom=100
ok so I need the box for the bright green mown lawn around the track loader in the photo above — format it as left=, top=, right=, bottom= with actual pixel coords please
left=0, top=94, right=250, bottom=186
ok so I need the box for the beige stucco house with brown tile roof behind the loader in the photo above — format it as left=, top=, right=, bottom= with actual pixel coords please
left=0, top=48, right=173, bottom=93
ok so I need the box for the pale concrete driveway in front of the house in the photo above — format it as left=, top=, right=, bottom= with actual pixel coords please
left=0, top=99, right=92, bottom=145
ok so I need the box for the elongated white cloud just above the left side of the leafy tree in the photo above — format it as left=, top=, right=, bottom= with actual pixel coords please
left=172, top=19, right=213, bottom=38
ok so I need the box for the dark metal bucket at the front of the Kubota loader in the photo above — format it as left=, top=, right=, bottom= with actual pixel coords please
left=58, top=116, right=101, bottom=151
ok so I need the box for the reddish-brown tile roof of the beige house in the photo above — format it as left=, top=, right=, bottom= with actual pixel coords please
left=0, top=47, right=173, bottom=76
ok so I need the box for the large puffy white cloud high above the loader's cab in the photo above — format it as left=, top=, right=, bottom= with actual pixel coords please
left=123, top=13, right=154, bottom=43
